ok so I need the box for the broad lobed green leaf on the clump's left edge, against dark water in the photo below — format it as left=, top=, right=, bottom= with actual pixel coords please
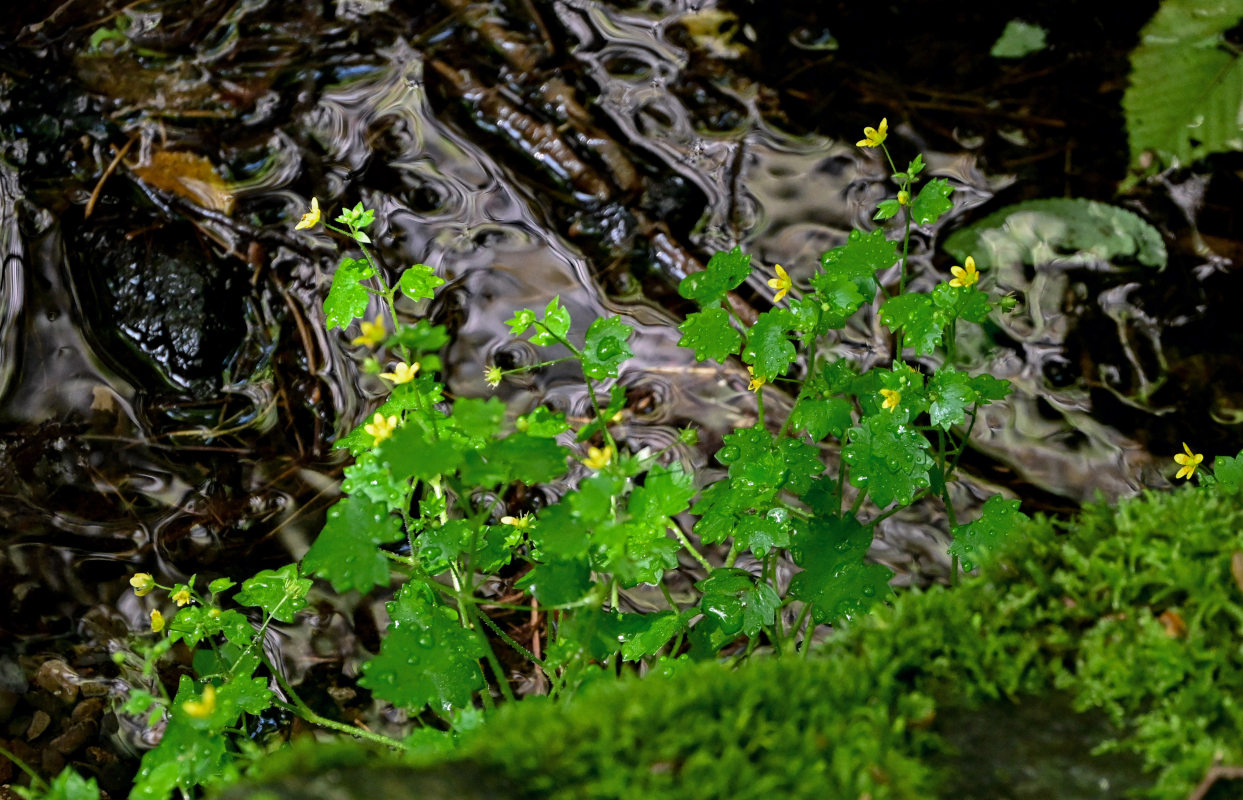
left=302, top=496, right=401, bottom=594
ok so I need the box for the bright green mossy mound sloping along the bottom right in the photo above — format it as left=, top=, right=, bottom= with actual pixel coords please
left=218, top=488, right=1243, bottom=800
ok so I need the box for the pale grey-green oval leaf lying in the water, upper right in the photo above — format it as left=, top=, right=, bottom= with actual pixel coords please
left=945, top=198, right=1166, bottom=274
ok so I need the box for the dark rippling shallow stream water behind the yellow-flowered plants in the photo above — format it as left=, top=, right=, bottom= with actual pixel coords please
left=0, top=0, right=1243, bottom=795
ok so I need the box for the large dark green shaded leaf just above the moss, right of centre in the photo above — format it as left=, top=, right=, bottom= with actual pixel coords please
left=789, top=517, right=894, bottom=622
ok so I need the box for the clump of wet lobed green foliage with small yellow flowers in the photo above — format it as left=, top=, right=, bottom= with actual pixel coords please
left=36, top=122, right=1022, bottom=799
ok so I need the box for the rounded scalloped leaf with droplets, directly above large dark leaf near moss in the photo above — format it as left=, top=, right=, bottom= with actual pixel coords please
left=842, top=411, right=932, bottom=508
